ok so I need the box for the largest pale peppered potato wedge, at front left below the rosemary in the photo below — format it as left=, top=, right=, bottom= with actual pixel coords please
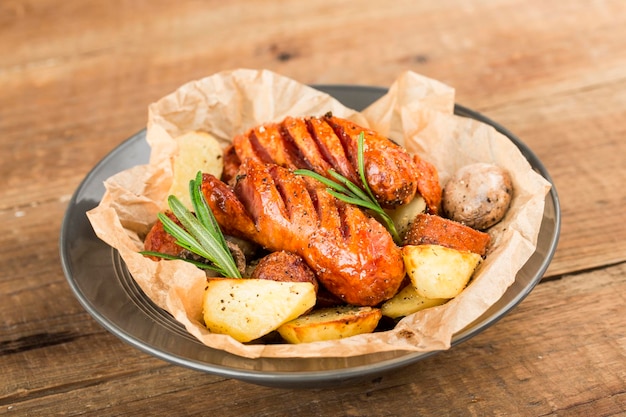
left=203, top=278, right=315, bottom=342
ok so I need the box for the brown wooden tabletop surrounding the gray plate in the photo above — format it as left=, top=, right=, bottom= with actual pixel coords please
left=0, top=0, right=626, bottom=416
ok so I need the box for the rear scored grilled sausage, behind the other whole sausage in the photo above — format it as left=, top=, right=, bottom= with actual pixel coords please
left=227, top=114, right=424, bottom=208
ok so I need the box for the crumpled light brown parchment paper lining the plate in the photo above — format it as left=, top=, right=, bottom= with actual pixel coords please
left=87, top=69, right=550, bottom=358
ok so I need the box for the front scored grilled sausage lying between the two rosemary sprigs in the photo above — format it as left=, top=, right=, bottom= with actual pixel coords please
left=202, top=159, right=405, bottom=306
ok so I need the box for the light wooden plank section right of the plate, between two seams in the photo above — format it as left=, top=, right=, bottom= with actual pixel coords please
left=486, top=74, right=626, bottom=276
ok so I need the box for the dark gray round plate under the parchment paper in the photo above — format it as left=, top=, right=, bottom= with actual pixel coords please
left=60, top=86, right=560, bottom=388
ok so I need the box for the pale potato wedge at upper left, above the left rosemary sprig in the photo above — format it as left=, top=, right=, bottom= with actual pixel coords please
left=168, top=131, right=224, bottom=209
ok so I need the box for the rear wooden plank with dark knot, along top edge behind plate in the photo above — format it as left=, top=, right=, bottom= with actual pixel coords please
left=0, top=0, right=625, bottom=98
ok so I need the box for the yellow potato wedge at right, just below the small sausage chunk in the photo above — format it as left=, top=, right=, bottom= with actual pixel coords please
left=402, top=245, right=482, bottom=298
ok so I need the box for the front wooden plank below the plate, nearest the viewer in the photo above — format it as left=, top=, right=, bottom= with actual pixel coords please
left=0, top=264, right=626, bottom=416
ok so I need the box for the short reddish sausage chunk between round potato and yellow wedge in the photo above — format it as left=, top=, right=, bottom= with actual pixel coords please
left=403, top=213, right=491, bottom=256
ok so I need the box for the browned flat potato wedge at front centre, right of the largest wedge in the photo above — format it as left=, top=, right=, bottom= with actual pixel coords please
left=278, top=306, right=382, bottom=343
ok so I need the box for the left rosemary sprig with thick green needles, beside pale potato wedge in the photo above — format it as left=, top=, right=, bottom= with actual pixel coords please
left=141, top=172, right=241, bottom=278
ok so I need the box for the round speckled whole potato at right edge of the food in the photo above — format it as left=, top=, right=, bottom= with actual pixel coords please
left=441, top=162, right=513, bottom=230
